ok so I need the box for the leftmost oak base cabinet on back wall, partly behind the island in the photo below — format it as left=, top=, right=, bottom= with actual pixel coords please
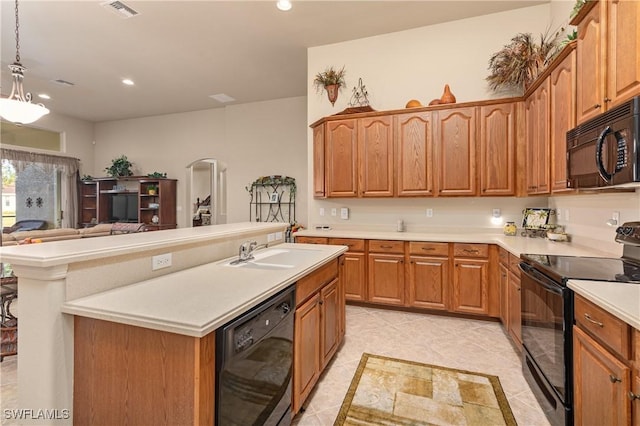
left=329, top=238, right=367, bottom=302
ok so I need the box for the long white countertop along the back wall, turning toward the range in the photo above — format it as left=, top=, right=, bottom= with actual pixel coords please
left=294, top=228, right=619, bottom=257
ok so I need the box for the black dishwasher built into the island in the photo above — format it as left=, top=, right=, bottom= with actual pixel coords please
left=215, top=285, right=295, bottom=426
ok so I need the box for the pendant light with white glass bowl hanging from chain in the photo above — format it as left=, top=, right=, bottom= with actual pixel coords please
left=0, top=0, right=49, bottom=124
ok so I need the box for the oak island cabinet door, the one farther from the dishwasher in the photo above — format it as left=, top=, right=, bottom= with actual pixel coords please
left=319, top=278, right=340, bottom=370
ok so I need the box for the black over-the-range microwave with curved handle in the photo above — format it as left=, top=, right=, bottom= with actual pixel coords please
left=567, top=96, right=640, bottom=189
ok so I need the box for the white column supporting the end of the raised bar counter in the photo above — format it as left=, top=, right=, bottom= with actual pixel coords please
left=13, top=265, right=73, bottom=425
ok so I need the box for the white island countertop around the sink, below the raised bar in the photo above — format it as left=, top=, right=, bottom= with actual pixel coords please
left=62, top=244, right=347, bottom=337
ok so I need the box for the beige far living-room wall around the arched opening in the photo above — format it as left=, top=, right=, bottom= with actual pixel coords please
left=94, top=97, right=307, bottom=227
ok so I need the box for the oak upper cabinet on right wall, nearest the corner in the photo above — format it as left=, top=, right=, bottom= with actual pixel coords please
left=525, top=78, right=550, bottom=195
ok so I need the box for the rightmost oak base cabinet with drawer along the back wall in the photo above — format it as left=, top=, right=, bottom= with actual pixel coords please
left=452, top=243, right=489, bottom=315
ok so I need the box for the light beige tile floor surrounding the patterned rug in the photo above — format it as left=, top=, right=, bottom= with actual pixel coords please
left=0, top=305, right=549, bottom=426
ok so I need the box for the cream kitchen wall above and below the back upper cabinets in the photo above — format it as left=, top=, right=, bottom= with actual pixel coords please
left=307, top=4, right=550, bottom=229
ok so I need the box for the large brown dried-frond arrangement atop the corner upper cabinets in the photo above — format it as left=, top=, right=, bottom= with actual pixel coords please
left=486, top=32, right=560, bottom=92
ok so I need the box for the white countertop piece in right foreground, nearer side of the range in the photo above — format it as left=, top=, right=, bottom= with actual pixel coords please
left=567, top=280, right=640, bottom=330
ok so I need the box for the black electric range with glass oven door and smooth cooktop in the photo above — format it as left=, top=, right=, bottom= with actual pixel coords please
left=520, top=222, right=640, bottom=426
